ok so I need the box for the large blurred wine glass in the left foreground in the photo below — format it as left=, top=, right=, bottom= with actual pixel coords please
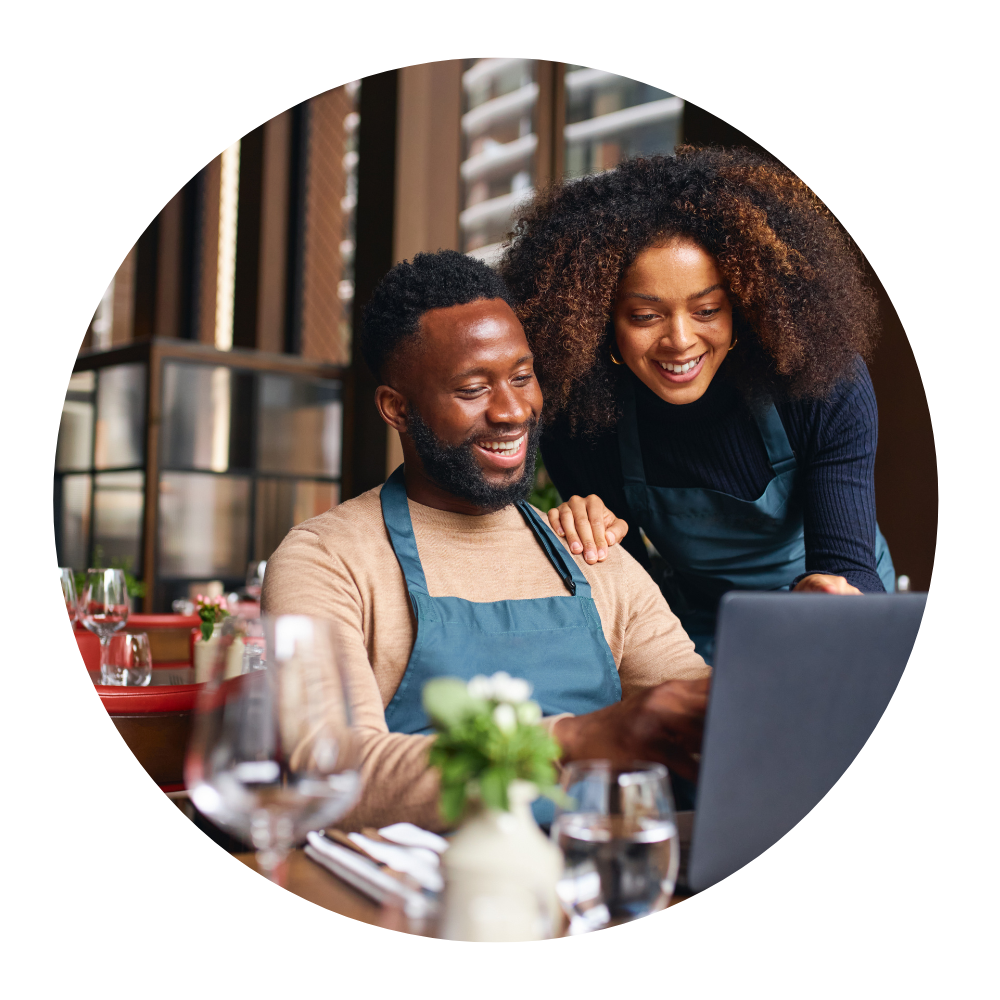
left=184, top=615, right=361, bottom=885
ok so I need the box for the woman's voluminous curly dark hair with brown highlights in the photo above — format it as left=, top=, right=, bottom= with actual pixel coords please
left=499, top=146, right=878, bottom=433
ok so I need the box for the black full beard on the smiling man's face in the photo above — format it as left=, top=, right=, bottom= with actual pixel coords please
left=407, top=407, right=542, bottom=514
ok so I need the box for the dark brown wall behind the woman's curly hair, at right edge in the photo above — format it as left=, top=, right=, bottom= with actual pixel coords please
left=683, top=104, right=937, bottom=590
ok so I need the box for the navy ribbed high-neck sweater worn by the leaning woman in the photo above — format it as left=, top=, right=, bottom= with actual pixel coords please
left=541, top=360, right=884, bottom=593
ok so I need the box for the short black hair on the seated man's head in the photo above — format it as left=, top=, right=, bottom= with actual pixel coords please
left=361, top=250, right=513, bottom=380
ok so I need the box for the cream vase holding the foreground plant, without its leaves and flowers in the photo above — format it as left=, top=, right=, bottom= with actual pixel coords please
left=440, top=781, right=563, bottom=941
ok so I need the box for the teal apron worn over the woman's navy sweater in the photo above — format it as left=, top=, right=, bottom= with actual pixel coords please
left=618, top=380, right=896, bottom=663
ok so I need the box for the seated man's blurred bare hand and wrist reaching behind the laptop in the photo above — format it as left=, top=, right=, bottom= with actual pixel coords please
left=552, top=678, right=710, bottom=781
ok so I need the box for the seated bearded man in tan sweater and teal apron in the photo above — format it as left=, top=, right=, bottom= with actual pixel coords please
left=262, top=251, right=709, bottom=829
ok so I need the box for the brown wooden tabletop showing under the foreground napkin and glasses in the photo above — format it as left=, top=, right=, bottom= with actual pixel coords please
left=233, top=813, right=694, bottom=937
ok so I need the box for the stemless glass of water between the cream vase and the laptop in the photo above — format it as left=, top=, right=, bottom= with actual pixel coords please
left=552, top=761, right=680, bottom=934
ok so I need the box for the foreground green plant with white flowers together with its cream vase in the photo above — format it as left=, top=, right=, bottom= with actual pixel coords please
left=423, top=672, right=564, bottom=941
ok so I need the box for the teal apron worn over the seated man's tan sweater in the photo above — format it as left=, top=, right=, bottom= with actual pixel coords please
left=381, top=466, right=622, bottom=822
